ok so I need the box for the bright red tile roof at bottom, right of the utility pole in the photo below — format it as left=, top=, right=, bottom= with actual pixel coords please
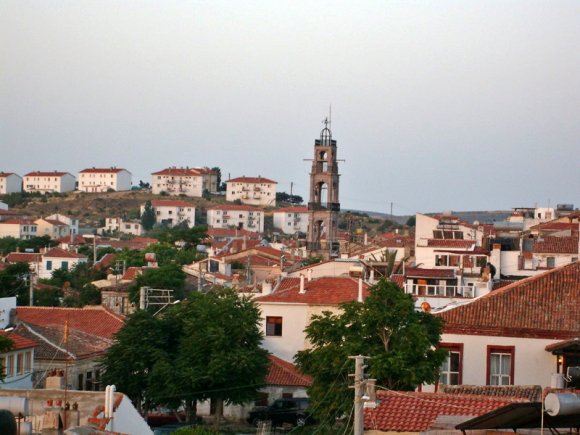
left=364, top=391, right=525, bottom=432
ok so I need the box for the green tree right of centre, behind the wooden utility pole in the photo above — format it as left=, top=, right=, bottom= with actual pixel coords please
left=295, top=280, right=446, bottom=430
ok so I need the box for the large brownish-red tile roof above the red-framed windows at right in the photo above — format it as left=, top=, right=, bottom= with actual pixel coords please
left=435, top=261, right=580, bottom=339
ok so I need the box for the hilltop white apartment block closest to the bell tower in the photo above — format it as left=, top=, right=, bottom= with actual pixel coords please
left=226, top=176, right=278, bottom=207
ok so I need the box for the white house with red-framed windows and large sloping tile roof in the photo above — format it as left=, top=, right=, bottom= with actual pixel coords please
left=436, top=262, right=580, bottom=387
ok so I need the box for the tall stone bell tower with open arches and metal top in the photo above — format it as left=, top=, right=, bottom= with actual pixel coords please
left=307, top=118, right=340, bottom=259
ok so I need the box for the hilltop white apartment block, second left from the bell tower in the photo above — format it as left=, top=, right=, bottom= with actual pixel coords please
left=151, top=166, right=218, bottom=198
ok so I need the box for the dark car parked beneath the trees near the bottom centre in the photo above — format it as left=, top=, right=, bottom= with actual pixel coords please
left=248, top=397, right=311, bottom=426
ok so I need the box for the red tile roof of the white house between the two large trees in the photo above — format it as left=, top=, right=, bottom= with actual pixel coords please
left=254, top=277, right=369, bottom=305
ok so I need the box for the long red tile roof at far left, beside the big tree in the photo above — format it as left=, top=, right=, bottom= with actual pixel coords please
left=16, top=306, right=124, bottom=339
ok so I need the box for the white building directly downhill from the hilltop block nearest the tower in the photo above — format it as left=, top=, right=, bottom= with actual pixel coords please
left=207, top=204, right=264, bottom=233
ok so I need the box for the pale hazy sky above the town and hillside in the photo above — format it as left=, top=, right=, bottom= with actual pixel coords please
left=0, top=0, right=580, bottom=214
